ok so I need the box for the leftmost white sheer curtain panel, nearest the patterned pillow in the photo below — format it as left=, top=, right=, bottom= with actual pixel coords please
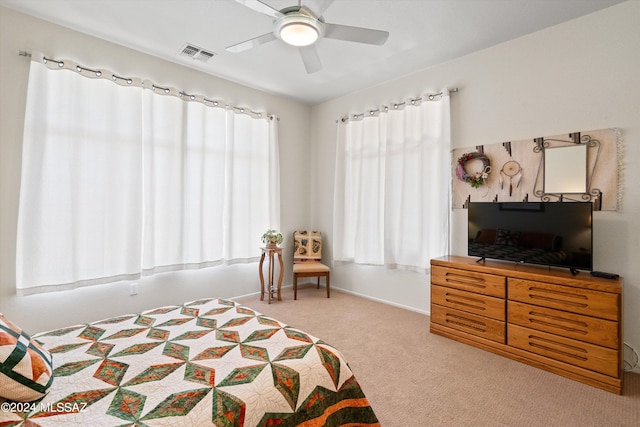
left=16, top=62, right=142, bottom=290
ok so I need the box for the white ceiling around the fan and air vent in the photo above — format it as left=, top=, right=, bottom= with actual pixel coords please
left=0, top=0, right=623, bottom=104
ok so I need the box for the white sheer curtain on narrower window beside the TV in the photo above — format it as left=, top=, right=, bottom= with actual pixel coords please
left=333, top=91, right=451, bottom=271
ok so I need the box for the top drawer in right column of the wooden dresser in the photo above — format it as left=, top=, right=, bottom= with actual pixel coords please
left=508, top=278, right=620, bottom=320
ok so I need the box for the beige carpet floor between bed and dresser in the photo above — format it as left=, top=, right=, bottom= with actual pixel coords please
left=237, top=286, right=640, bottom=427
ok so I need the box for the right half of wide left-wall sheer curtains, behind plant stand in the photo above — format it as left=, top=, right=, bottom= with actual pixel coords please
left=143, top=91, right=279, bottom=272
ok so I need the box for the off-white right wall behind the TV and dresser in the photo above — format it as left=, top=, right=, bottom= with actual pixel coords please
left=311, top=0, right=640, bottom=368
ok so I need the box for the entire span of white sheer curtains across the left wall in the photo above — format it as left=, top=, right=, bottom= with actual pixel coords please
left=16, top=58, right=280, bottom=294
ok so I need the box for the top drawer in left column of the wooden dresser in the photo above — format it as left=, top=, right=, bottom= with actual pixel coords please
left=431, top=266, right=506, bottom=298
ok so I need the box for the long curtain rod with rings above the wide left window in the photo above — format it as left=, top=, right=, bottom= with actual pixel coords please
left=18, top=50, right=280, bottom=121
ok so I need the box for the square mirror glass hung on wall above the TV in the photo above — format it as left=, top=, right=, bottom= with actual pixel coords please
left=543, top=144, right=587, bottom=194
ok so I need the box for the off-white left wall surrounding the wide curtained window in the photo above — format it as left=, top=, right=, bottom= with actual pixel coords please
left=0, top=7, right=311, bottom=332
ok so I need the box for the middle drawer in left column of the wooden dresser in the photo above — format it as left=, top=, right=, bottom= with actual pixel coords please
left=431, top=285, right=506, bottom=321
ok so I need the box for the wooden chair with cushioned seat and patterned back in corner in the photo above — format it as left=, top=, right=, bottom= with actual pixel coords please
left=293, top=230, right=331, bottom=300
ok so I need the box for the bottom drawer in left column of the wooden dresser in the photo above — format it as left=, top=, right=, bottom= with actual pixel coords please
left=431, top=304, right=505, bottom=344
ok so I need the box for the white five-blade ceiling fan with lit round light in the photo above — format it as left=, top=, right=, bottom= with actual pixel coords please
left=226, top=0, right=389, bottom=74
